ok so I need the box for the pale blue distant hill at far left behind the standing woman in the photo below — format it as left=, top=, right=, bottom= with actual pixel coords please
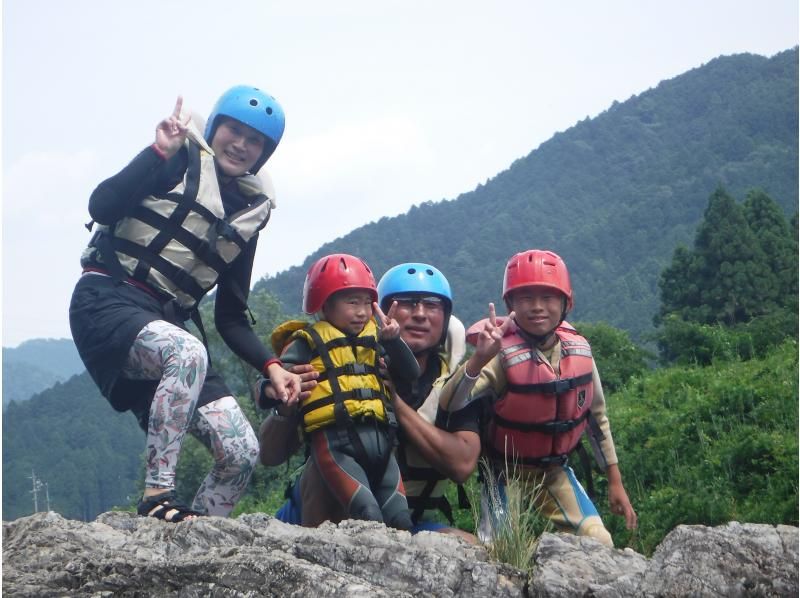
left=3, top=338, right=84, bottom=409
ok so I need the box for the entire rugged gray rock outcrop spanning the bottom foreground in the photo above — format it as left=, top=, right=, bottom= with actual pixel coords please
left=3, top=513, right=798, bottom=598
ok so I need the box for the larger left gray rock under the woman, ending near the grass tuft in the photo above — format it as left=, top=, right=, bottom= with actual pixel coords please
left=3, top=513, right=526, bottom=598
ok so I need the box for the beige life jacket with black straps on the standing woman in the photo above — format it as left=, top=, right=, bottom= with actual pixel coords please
left=81, top=122, right=273, bottom=310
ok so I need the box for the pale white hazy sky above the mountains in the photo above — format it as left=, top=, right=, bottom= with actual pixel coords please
left=2, top=0, right=798, bottom=347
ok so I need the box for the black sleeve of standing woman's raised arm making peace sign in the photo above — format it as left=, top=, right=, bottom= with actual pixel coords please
left=89, top=147, right=187, bottom=225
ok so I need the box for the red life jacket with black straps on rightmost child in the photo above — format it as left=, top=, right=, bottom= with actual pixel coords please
left=487, top=323, right=593, bottom=466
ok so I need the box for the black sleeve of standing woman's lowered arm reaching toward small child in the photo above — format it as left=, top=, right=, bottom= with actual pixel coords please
left=214, top=235, right=272, bottom=372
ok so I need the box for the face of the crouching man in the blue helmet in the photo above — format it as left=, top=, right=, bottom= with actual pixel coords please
left=389, top=294, right=445, bottom=355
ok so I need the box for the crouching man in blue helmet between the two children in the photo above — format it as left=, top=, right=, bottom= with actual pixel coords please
left=257, top=263, right=480, bottom=542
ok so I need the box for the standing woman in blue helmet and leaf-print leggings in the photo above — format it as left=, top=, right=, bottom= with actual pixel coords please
left=70, top=85, right=300, bottom=522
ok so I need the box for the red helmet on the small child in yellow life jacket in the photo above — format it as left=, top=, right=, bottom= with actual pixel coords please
left=303, top=253, right=378, bottom=314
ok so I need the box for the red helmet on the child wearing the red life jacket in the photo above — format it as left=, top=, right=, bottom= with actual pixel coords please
left=503, top=249, right=572, bottom=311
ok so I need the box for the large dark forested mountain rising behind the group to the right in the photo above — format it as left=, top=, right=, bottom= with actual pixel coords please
left=256, top=48, right=798, bottom=339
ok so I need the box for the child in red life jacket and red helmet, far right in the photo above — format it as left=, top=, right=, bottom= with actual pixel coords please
left=440, top=249, right=637, bottom=546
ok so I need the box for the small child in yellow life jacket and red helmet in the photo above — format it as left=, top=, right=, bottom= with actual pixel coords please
left=258, top=254, right=420, bottom=529
